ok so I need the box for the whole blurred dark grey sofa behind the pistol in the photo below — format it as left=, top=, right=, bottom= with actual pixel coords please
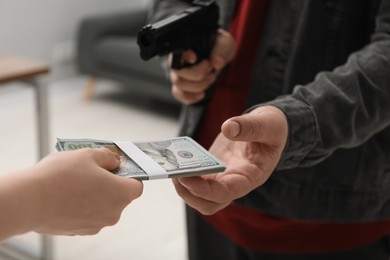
left=76, top=7, right=178, bottom=104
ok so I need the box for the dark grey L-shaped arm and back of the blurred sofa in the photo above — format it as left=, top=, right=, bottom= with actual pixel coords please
left=76, top=8, right=147, bottom=72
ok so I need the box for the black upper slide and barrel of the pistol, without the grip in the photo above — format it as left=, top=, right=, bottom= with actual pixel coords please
left=137, top=2, right=219, bottom=60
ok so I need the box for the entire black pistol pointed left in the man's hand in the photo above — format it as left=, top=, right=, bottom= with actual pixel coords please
left=137, top=0, right=219, bottom=69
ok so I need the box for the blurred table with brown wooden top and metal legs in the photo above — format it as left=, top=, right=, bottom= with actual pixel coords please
left=0, top=54, right=53, bottom=260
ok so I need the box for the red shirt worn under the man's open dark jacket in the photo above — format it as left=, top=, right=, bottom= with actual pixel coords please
left=195, top=0, right=390, bottom=253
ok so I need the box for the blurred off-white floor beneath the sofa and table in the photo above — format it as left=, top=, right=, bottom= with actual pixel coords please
left=0, top=77, right=187, bottom=260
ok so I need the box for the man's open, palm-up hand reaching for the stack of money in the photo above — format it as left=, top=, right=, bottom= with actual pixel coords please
left=173, top=106, right=288, bottom=215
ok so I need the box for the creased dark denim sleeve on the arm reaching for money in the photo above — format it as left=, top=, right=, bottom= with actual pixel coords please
left=267, top=1, right=390, bottom=169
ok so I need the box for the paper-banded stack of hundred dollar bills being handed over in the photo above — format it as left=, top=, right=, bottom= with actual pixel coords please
left=56, top=136, right=225, bottom=180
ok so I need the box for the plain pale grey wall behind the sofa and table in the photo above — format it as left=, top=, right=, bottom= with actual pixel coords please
left=0, top=0, right=148, bottom=68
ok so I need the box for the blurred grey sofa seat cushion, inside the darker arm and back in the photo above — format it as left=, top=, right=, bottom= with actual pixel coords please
left=94, top=36, right=167, bottom=81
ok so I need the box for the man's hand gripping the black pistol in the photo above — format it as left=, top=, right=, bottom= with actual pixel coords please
left=169, top=29, right=236, bottom=104
